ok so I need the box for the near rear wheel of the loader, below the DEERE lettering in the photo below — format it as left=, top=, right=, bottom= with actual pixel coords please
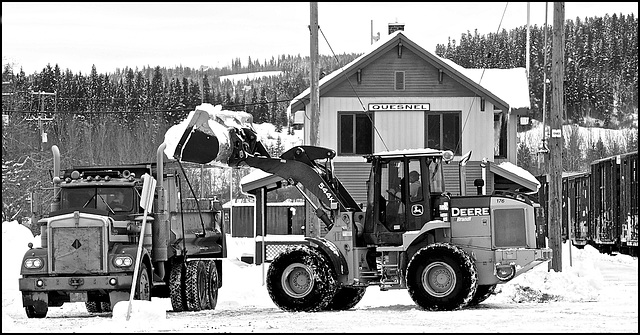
left=406, top=243, right=478, bottom=311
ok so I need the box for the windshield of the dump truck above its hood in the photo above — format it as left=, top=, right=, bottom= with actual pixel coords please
left=61, top=187, right=134, bottom=212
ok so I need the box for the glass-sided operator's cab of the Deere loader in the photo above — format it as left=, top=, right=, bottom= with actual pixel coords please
left=364, top=149, right=444, bottom=245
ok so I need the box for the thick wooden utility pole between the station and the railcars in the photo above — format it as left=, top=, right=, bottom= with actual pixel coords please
left=549, top=2, right=571, bottom=272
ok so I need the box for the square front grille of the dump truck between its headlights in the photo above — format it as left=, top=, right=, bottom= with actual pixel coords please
left=49, top=218, right=107, bottom=274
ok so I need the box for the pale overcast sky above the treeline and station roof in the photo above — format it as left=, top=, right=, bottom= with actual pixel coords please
left=2, top=2, right=638, bottom=74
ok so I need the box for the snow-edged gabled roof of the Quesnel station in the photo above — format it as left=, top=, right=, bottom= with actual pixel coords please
left=289, top=30, right=530, bottom=111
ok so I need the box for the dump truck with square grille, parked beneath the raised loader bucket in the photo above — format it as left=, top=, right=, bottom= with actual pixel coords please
left=19, top=143, right=226, bottom=318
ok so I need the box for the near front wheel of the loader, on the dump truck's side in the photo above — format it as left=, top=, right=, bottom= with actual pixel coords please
left=267, top=245, right=337, bottom=312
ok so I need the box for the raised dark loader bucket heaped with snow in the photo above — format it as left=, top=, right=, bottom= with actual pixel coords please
left=173, top=110, right=220, bottom=164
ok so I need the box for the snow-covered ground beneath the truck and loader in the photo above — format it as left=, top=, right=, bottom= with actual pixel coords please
left=2, top=222, right=638, bottom=333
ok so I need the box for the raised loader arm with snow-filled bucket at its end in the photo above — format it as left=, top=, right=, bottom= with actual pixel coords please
left=172, top=105, right=361, bottom=230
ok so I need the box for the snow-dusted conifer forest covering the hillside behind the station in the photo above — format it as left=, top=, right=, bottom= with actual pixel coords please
left=2, top=14, right=638, bottom=221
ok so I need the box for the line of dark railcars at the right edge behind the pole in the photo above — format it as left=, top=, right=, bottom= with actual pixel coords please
left=537, top=152, right=639, bottom=256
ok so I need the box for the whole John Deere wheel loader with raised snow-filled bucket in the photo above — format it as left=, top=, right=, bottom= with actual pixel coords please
left=165, top=108, right=552, bottom=312
